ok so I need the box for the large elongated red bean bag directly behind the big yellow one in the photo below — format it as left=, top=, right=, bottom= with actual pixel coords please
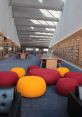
left=29, top=68, right=60, bottom=85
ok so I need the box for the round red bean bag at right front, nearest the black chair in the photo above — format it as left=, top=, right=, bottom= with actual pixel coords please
left=56, top=78, right=78, bottom=96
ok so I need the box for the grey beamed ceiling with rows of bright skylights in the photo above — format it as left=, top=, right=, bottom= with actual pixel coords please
left=11, top=0, right=63, bottom=47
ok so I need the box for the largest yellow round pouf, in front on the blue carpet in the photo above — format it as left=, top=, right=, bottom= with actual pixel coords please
left=17, top=76, right=46, bottom=98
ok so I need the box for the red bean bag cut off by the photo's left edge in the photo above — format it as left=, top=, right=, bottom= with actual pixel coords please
left=0, top=71, right=18, bottom=87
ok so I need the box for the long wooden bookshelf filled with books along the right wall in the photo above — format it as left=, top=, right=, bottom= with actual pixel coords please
left=52, top=29, right=82, bottom=68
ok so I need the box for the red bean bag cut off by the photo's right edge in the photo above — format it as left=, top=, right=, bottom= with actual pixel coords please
left=65, top=72, right=82, bottom=85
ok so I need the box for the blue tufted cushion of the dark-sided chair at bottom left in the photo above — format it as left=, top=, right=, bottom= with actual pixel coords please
left=0, top=88, right=14, bottom=114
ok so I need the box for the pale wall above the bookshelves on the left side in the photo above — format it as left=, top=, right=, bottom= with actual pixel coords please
left=0, top=0, right=20, bottom=45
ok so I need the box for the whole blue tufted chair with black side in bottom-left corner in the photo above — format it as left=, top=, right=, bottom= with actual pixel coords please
left=0, top=87, right=21, bottom=117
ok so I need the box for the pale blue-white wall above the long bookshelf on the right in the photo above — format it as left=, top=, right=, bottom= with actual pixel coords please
left=49, top=0, right=82, bottom=47
